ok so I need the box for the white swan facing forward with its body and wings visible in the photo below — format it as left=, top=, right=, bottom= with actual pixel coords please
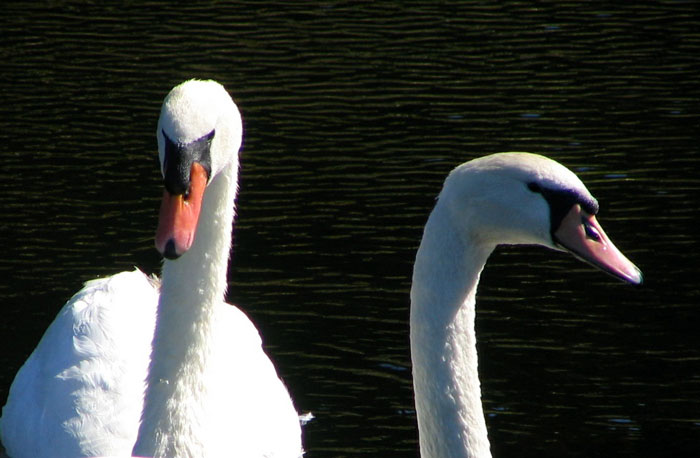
left=0, top=80, right=302, bottom=458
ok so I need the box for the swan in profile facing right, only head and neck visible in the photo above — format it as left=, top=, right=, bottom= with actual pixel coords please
left=410, top=153, right=642, bottom=458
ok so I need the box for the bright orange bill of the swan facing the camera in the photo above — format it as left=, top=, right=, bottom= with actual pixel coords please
left=156, top=162, right=207, bottom=259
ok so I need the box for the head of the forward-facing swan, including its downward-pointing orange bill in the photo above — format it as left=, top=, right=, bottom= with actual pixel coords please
left=156, top=80, right=243, bottom=259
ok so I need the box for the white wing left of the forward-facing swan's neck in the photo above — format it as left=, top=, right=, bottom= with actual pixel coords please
left=0, top=270, right=158, bottom=457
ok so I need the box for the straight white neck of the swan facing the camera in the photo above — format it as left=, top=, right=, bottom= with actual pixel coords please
left=133, top=165, right=238, bottom=457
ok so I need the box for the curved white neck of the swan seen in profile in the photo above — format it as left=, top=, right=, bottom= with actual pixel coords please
left=411, top=203, right=494, bottom=458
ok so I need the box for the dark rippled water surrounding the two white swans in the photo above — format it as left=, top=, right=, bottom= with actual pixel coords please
left=0, top=1, right=700, bottom=458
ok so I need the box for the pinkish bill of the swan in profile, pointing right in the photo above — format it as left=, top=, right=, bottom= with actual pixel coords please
left=554, top=205, right=642, bottom=285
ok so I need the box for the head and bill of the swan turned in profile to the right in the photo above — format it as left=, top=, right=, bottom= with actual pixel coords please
left=438, top=153, right=642, bottom=284
